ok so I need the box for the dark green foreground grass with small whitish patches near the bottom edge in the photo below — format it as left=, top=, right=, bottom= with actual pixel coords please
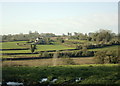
left=3, top=64, right=120, bottom=86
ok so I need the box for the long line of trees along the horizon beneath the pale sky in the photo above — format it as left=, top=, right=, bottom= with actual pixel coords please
left=2, top=29, right=120, bottom=42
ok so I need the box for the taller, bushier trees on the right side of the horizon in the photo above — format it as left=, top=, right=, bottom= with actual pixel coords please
left=70, top=29, right=120, bottom=42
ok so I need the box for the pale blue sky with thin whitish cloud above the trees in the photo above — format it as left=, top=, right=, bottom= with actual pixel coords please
left=0, top=2, right=118, bottom=34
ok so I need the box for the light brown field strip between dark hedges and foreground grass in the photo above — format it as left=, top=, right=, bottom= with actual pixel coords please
left=3, top=57, right=95, bottom=66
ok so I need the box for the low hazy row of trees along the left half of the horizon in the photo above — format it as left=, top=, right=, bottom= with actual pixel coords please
left=2, top=31, right=56, bottom=41
